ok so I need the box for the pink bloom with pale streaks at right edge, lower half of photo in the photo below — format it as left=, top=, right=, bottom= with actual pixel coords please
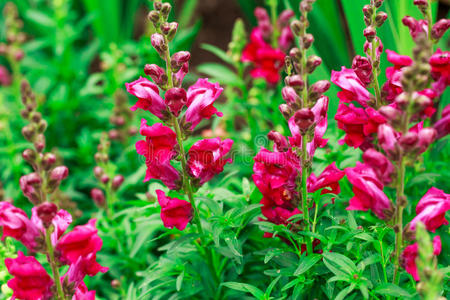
left=409, top=187, right=450, bottom=232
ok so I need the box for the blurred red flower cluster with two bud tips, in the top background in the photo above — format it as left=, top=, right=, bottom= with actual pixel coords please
left=242, top=7, right=294, bottom=84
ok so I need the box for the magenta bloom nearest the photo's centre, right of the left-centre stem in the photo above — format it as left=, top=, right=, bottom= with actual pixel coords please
left=187, top=137, right=233, bottom=184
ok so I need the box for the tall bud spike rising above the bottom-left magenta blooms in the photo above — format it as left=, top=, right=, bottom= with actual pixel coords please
left=20, top=81, right=69, bottom=205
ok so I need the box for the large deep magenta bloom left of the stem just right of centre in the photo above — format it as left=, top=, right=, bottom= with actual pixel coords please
left=253, top=148, right=301, bottom=205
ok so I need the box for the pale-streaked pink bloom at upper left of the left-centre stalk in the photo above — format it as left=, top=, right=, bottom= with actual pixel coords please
left=125, top=77, right=167, bottom=120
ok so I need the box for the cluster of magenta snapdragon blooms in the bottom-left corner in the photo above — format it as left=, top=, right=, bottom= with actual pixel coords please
left=0, top=202, right=108, bottom=300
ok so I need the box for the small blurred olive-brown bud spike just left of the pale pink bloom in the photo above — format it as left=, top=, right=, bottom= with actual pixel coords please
left=108, top=90, right=138, bottom=143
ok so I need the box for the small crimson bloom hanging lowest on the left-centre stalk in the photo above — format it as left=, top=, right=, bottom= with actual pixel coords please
left=156, top=190, right=192, bottom=230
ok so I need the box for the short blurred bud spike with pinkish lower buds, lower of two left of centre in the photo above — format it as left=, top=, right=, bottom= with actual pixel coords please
left=91, top=134, right=124, bottom=208
